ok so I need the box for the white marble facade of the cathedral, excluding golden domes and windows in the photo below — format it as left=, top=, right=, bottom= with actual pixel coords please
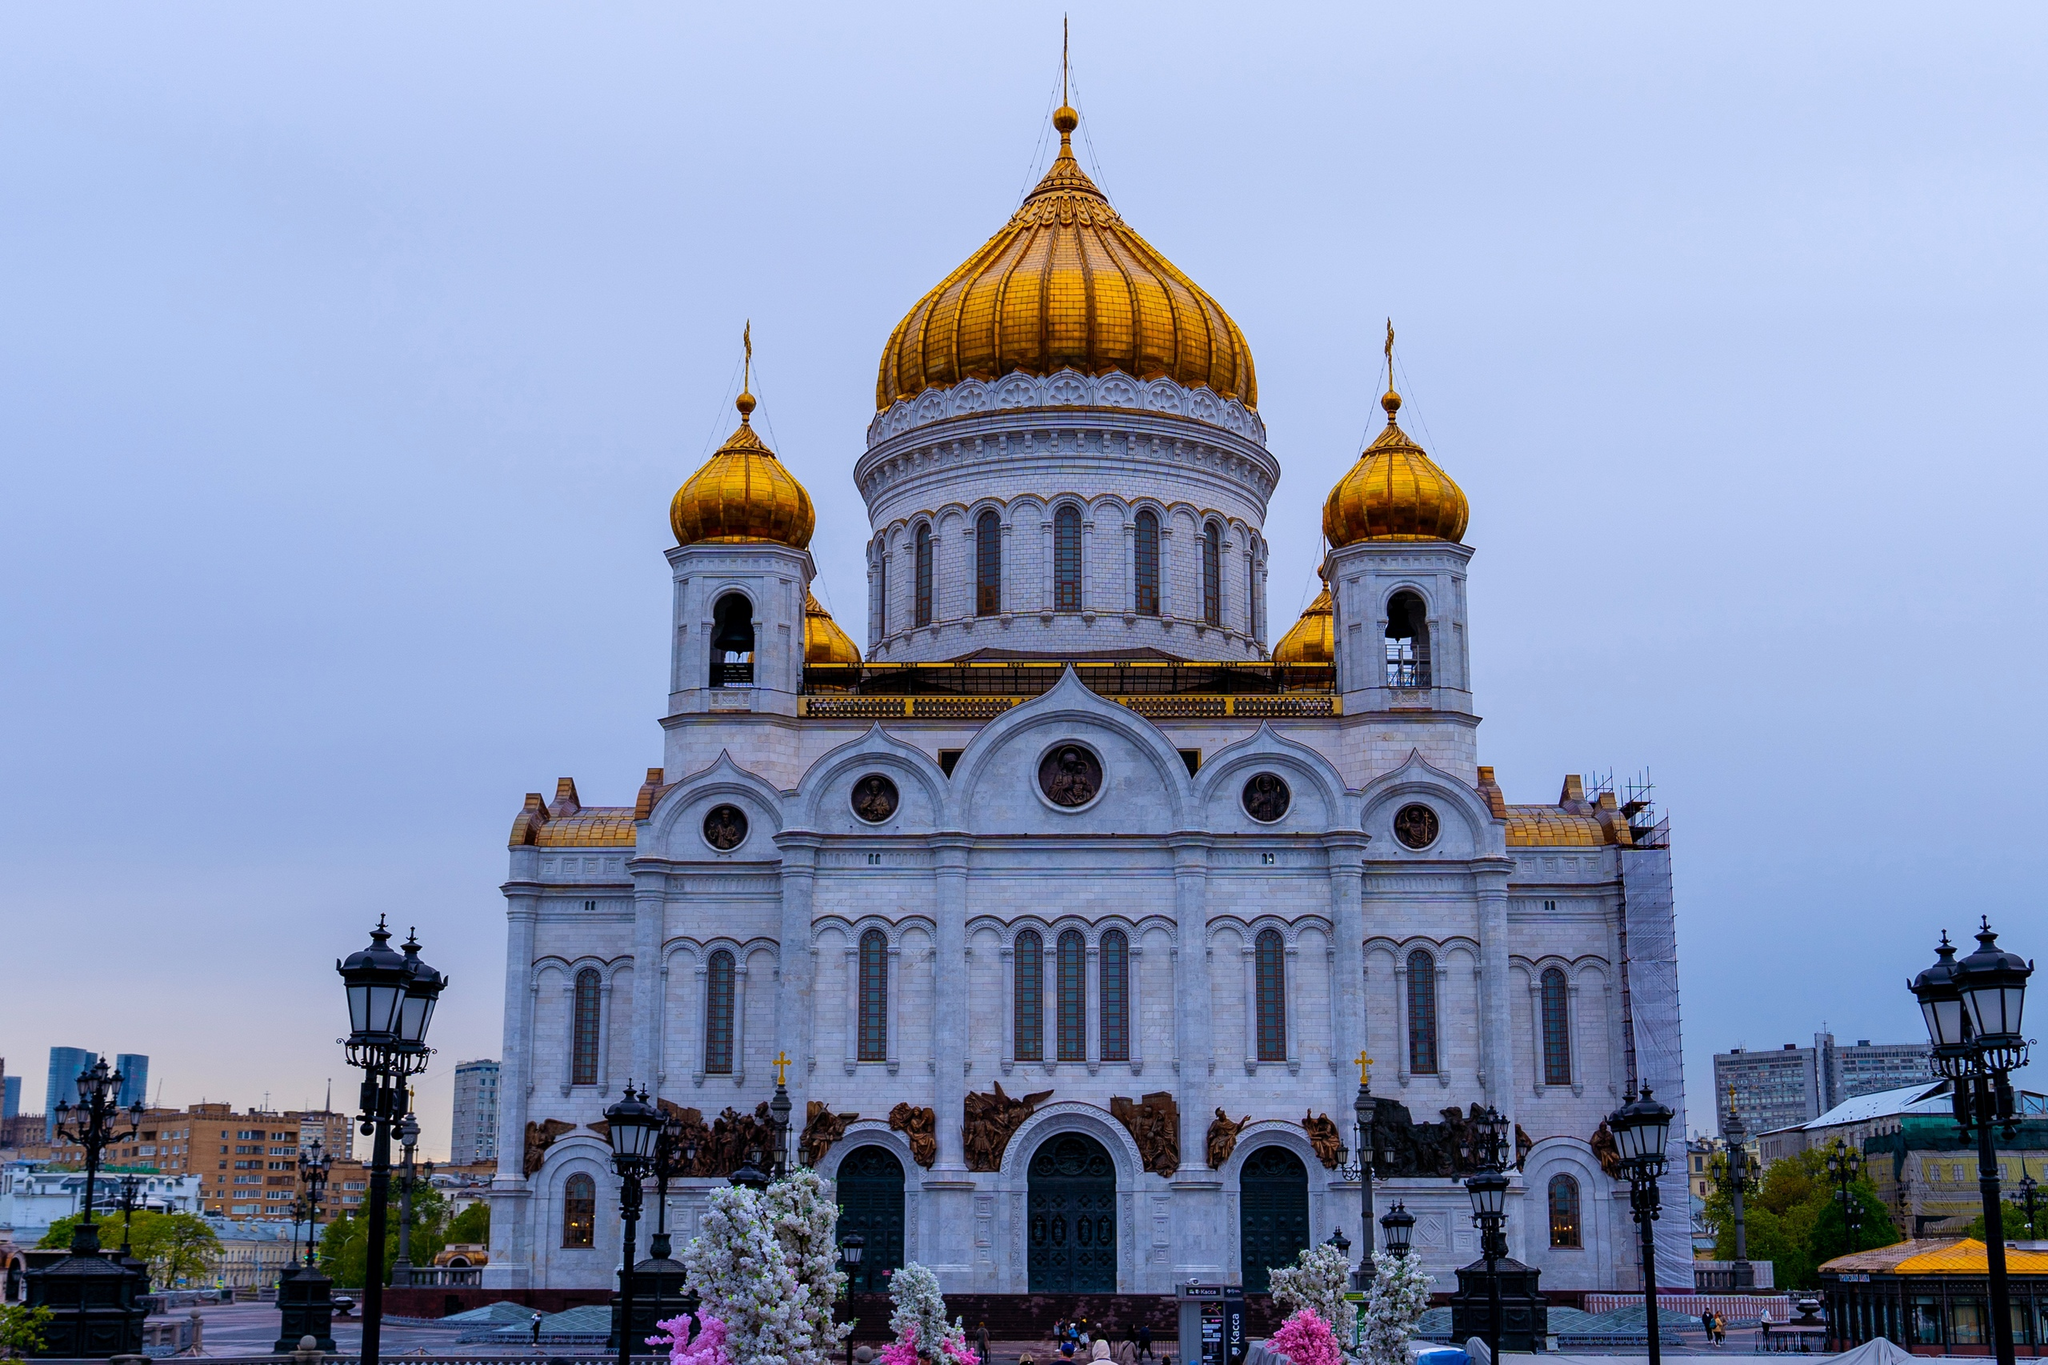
left=485, top=358, right=1688, bottom=1293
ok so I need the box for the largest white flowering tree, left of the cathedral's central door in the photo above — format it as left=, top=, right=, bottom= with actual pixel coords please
left=682, top=1166, right=852, bottom=1365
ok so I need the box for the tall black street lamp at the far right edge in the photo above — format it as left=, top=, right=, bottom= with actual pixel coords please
left=1909, top=919, right=2034, bottom=1365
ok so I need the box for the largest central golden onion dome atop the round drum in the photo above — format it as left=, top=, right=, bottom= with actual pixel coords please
left=874, top=104, right=1260, bottom=409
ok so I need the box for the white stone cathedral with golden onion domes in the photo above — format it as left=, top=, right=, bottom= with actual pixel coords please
left=485, top=93, right=1692, bottom=1293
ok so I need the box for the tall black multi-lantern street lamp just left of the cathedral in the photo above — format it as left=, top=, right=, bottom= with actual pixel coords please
left=334, top=917, right=449, bottom=1361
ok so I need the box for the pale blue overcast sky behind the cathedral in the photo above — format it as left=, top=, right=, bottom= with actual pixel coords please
left=0, top=2, right=2048, bottom=1152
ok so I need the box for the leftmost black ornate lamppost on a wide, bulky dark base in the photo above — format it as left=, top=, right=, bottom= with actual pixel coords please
left=29, top=1058, right=147, bottom=1357
